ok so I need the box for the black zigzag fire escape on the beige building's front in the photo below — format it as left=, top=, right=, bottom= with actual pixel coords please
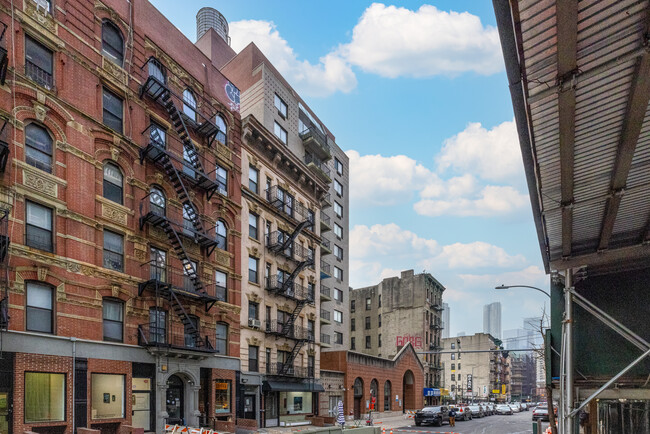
left=266, top=186, right=315, bottom=376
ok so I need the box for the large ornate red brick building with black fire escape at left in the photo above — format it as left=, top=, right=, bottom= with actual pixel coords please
left=0, top=0, right=241, bottom=434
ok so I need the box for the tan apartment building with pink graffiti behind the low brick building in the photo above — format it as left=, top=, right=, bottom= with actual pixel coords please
left=350, top=270, right=445, bottom=404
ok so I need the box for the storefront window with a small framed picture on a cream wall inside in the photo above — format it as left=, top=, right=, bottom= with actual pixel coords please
left=91, top=374, right=124, bottom=419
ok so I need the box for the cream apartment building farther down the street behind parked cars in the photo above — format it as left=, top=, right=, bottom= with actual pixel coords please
left=441, top=333, right=510, bottom=402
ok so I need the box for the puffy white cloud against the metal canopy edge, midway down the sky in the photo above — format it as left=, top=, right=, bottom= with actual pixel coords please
left=436, top=120, right=524, bottom=181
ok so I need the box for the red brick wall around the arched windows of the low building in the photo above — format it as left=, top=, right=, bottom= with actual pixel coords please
left=321, top=348, right=424, bottom=415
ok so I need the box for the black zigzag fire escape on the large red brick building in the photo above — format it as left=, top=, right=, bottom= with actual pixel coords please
left=138, top=59, right=218, bottom=351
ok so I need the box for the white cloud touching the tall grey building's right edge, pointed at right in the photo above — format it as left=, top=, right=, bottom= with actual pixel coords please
left=346, top=151, right=438, bottom=205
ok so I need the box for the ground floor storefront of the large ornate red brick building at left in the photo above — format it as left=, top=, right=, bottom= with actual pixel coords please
left=0, top=332, right=239, bottom=434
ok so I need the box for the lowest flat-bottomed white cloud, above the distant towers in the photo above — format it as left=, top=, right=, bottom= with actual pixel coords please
left=422, top=241, right=526, bottom=269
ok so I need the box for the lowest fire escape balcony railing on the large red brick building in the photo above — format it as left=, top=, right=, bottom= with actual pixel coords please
left=138, top=323, right=215, bottom=353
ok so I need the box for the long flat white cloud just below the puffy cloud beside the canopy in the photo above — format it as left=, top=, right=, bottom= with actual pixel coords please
left=413, top=185, right=528, bottom=217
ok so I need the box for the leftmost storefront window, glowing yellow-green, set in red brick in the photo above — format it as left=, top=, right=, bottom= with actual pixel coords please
left=25, top=372, right=66, bottom=423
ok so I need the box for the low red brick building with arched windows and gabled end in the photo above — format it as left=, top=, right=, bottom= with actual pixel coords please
left=321, top=343, right=424, bottom=419
